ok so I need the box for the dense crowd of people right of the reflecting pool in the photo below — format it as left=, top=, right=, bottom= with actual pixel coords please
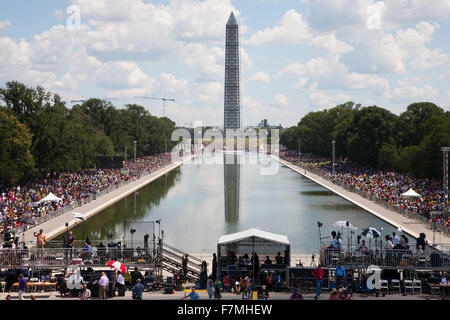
left=280, top=151, right=450, bottom=227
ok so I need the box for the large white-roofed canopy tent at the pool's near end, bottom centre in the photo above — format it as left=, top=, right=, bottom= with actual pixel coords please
left=217, top=228, right=290, bottom=260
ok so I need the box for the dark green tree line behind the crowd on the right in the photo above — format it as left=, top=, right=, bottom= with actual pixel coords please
left=280, top=101, right=450, bottom=178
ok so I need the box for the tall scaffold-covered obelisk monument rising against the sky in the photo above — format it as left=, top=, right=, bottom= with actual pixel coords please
left=223, top=12, right=241, bottom=134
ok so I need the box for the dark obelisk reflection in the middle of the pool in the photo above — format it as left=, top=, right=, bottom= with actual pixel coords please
left=223, top=153, right=241, bottom=223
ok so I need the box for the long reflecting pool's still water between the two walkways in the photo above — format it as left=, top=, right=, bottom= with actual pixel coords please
left=62, top=154, right=396, bottom=253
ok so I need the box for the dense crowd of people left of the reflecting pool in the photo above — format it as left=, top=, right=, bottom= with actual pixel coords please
left=0, top=153, right=171, bottom=239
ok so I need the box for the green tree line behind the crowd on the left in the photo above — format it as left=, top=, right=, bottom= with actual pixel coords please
left=0, top=81, right=175, bottom=185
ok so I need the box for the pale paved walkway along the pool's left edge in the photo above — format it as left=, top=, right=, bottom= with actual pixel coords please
left=20, top=155, right=195, bottom=243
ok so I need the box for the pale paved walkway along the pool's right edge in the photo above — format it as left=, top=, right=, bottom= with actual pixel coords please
left=271, top=155, right=450, bottom=248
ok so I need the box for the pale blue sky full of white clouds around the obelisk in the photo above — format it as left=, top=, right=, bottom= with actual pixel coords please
left=0, top=0, right=450, bottom=126
